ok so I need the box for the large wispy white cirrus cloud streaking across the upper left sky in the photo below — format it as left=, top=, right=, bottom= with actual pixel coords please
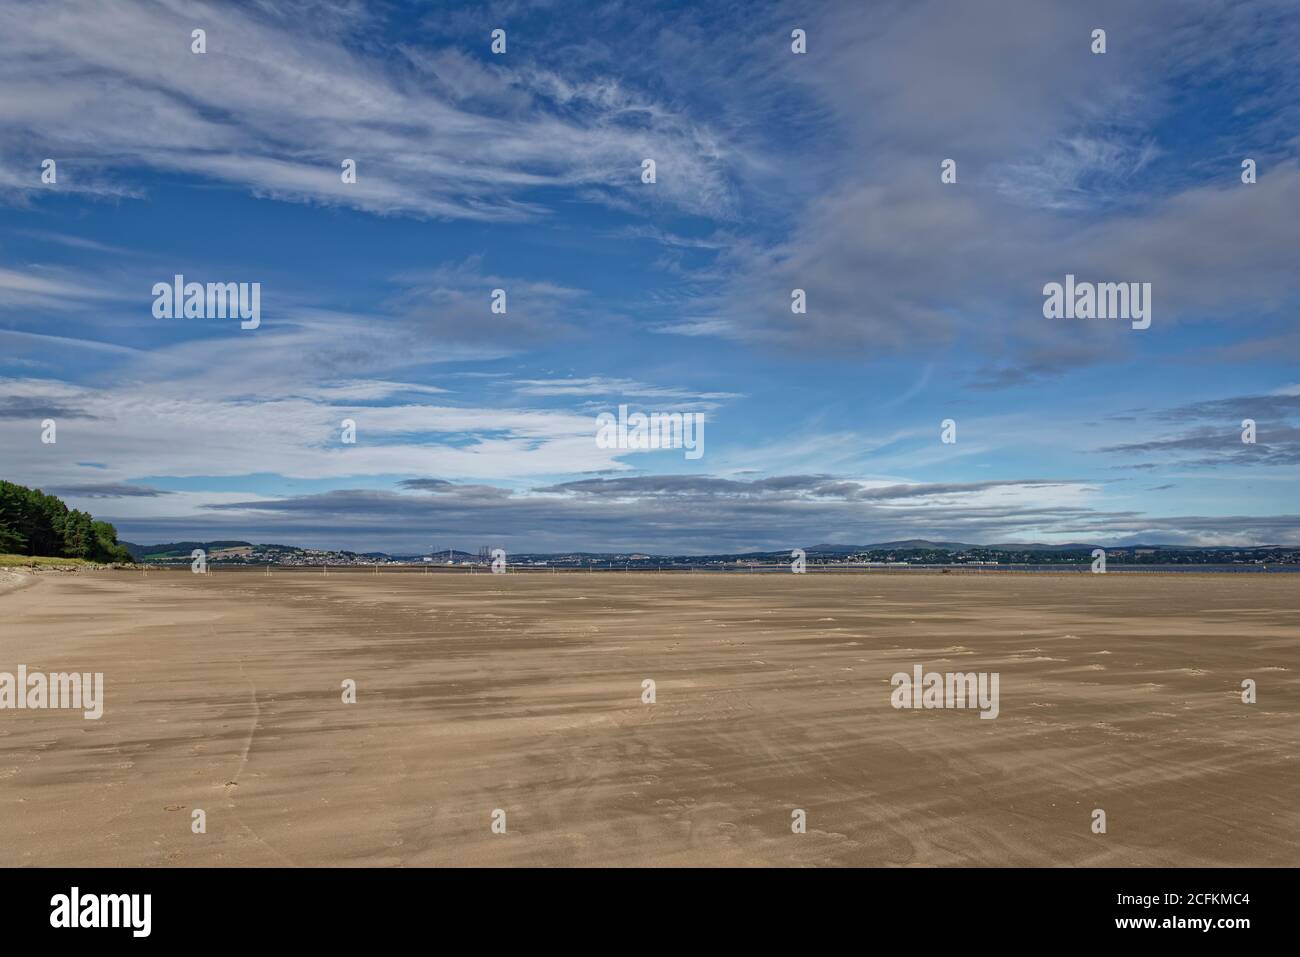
left=0, top=0, right=731, bottom=221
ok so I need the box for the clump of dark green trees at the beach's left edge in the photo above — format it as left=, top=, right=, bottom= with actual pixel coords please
left=0, top=481, right=131, bottom=562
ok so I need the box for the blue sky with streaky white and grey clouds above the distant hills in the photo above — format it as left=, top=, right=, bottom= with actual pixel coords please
left=0, top=0, right=1300, bottom=554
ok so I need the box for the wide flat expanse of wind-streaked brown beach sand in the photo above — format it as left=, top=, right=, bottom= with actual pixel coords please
left=0, top=568, right=1300, bottom=866
